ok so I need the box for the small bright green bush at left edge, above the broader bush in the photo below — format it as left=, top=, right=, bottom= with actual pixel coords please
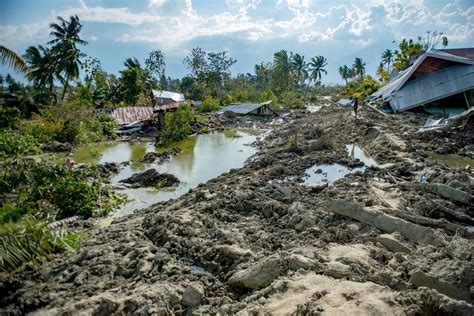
left=0, top=128, right=38, bottom=158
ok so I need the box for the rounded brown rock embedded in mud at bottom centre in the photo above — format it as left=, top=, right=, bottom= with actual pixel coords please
left=228, top=257, right=283, bottom=289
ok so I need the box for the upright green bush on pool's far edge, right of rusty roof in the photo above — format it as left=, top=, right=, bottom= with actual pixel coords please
left=156, top=103, right=194, bottom=144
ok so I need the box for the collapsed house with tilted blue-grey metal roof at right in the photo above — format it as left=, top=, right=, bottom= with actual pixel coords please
left=369, top=48, right=474, bottom=114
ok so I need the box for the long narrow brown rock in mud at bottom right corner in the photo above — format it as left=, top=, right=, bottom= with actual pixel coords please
left=408, top=271, right=471, bottom=302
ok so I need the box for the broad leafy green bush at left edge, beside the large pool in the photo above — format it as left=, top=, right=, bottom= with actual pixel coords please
left=0, top=159, right=121, bottom=224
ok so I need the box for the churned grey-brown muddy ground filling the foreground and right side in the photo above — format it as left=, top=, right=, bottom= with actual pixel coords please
left=0, top=106, right=474, bottom=315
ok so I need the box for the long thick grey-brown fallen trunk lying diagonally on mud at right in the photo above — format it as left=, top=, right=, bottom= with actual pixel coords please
left=329, top=200, right=443, bottom=246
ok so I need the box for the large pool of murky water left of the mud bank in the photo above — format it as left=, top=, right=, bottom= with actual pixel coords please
left=74, top=131, right=257, bottom=215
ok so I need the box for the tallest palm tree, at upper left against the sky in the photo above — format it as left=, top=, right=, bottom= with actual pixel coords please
left=48, top=15, right=87, bottom=99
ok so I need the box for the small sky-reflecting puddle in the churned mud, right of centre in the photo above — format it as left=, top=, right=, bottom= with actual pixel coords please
left=304, top=144, right=377, bottom=186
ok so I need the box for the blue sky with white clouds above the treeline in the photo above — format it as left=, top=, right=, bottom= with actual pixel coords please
left=0, top=0, right=474, bottom=84
